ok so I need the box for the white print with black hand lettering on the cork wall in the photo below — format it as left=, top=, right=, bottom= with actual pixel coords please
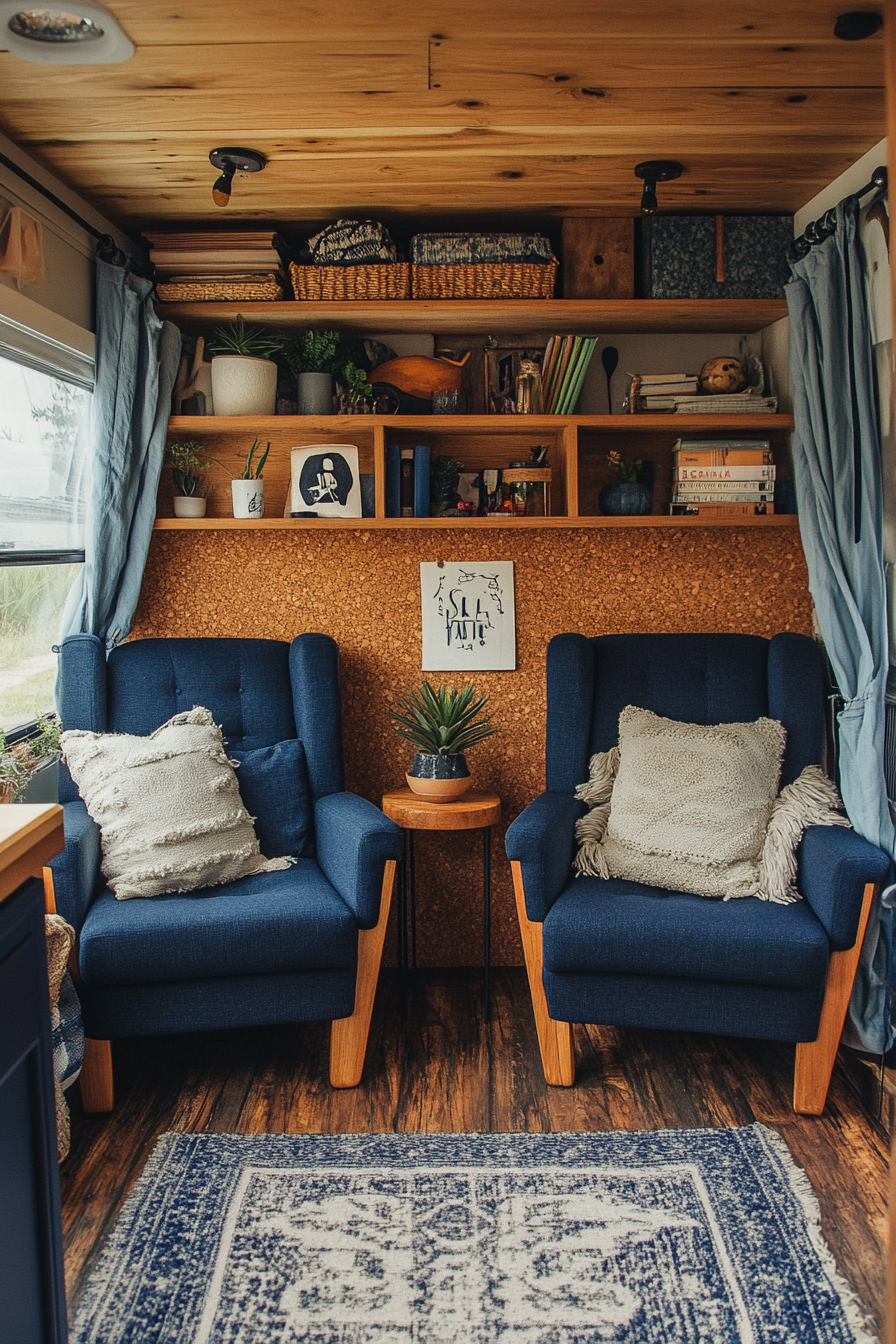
left=420, top=560, right=516, bottom=672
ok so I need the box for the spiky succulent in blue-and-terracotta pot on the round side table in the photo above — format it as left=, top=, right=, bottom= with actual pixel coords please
left=391, top=681, right=496, bottom=802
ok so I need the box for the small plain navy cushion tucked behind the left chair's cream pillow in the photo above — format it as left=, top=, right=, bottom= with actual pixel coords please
left=228, top=738, right=314, bottom=859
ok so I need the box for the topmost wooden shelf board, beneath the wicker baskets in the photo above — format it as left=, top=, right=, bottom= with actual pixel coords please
left=156, top=298, right=787, bottom=336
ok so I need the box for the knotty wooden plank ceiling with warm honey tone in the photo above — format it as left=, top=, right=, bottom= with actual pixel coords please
left=0, top=0, right=884, bottom=227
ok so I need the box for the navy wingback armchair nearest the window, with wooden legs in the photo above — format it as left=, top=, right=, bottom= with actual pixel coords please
left=52, top=634, right=402, bottom=1110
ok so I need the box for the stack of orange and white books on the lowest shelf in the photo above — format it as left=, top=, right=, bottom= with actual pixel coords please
left=669, top=438, right=775, bottom=517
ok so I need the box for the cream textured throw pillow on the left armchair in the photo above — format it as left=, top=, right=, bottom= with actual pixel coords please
left=59, top=707, right=292, bottom=900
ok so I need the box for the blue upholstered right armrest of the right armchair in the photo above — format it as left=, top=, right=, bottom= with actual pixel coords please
left=797, top=827, right=889, bottom=952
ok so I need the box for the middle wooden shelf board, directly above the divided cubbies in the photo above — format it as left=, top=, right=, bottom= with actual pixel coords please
left=168, top=414, right=794, bottom=438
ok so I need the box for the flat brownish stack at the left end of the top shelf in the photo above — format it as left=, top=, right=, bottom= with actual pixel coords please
left=145, top=230, right=286, bottom=302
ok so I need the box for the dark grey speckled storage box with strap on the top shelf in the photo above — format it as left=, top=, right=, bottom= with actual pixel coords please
left=638, top=215, right=794, bottom=298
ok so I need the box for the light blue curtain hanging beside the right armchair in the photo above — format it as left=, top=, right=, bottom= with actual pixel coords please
left=786, top=200, right=896, bottom=1054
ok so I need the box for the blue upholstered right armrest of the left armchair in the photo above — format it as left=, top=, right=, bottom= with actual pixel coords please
left=314, top=793, right=404, bottom=929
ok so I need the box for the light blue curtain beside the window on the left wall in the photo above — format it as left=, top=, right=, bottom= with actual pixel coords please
left=62, top=261, right=180, bottom=649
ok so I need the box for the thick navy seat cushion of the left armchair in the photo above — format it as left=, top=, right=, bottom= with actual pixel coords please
left=79, top=859, right=357, bottom=985
